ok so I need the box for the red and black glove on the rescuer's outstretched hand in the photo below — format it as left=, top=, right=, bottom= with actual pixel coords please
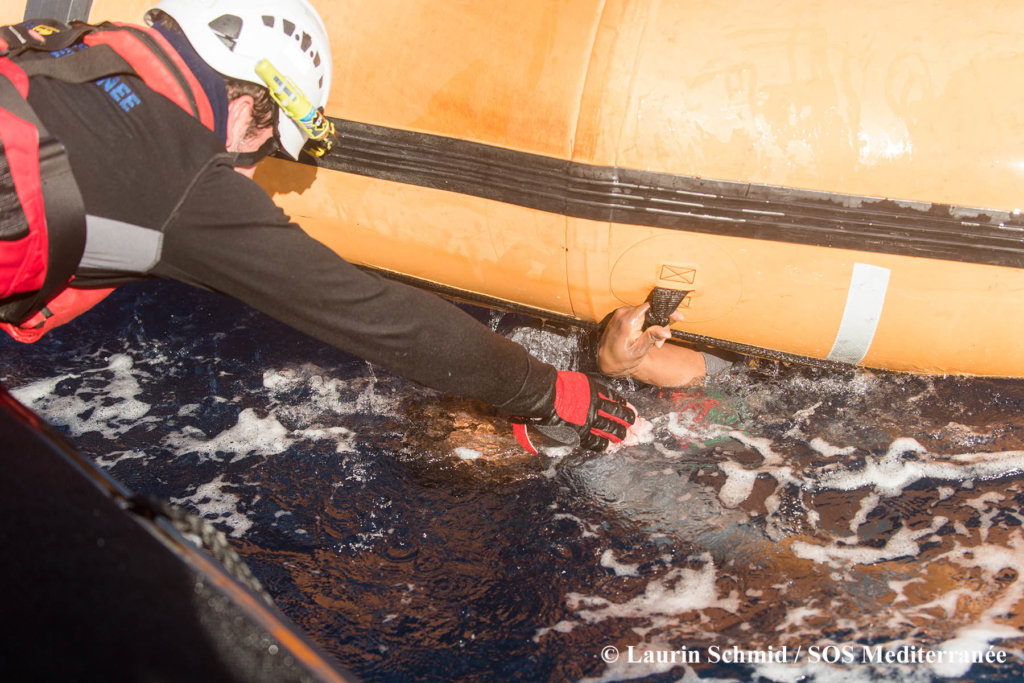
left=511, top=372, right=636, bottom=454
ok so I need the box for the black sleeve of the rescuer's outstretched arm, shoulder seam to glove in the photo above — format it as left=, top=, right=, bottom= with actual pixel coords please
left=152, top=160, right=556, bottom=417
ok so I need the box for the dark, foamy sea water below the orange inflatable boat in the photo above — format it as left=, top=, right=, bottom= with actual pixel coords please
left=0, top=283, right=1024, bottom=682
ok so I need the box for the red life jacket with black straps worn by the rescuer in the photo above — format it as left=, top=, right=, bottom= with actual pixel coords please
left=0, top=20, right=214, bottom=343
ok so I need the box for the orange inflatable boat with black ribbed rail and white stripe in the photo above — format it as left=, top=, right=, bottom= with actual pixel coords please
left=12, top=0, right=1024, bottom=377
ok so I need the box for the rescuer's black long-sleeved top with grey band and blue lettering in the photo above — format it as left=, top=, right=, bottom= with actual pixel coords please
left=28, top=31, right=556, bottom=417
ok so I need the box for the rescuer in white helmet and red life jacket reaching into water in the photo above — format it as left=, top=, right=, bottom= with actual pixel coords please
left=0, top=0, right=716, bottom=453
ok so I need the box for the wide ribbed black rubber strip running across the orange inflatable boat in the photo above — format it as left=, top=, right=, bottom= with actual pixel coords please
left=303, top=119, right=1024, bottom=268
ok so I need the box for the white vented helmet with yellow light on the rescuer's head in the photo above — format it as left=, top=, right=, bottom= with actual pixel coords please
left=145, top=0, right=332, bottom=159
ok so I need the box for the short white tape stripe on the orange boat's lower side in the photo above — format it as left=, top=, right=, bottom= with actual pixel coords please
left=827, top=263, right=891, bottom=366
